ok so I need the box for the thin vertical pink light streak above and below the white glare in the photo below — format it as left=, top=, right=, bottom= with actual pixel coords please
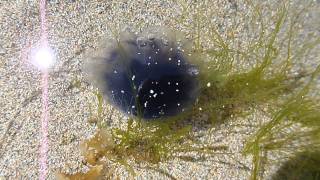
left=39, top=0, right=49, bottom=180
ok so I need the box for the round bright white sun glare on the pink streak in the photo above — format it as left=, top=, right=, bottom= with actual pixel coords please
left=31, top=47, right=55, bottom=71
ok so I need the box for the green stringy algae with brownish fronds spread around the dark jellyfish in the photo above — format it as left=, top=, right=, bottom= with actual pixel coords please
left=58, top=1, right=320, bottom=179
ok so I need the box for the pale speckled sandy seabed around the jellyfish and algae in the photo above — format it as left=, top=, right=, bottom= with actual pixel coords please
left=0, top=0, right=320, bottom=180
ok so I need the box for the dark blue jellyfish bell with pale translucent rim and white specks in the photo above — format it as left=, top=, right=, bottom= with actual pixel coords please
left=84, top=28, right=199, bottom=119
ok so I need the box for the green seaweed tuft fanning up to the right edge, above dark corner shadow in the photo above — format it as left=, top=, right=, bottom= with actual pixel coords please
left=244, top=66, right=320, bottom=179
